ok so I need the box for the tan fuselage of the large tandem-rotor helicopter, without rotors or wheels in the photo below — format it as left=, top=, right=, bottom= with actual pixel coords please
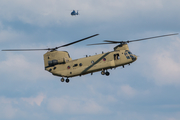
left=44, top=44, right=137, bottom=77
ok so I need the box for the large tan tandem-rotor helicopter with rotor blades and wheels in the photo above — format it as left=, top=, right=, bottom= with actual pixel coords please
left=2, top=33, right=178, bottom=83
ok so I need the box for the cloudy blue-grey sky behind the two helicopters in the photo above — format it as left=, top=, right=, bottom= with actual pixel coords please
left=0, top=0, right=180, bottom=120
